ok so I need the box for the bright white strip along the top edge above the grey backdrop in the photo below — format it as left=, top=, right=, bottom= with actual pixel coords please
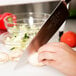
left=0, top=0, right=58, bottom=6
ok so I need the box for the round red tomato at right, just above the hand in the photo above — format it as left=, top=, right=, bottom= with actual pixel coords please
left=60, top=31, right=76, bottom=47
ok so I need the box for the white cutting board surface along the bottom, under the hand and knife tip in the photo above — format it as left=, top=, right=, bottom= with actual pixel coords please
left=0, top=62, right=65, bottom=76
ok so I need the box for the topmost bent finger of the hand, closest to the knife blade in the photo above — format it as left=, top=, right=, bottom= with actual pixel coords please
left=38, top=42, right=65, bottom=53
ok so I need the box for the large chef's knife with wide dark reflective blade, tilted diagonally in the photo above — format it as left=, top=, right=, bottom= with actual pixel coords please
left=15, top=0, right=70, bottom=69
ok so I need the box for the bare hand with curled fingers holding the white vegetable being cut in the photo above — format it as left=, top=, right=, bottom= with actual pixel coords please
left=38, top=42, right=76, bottom=76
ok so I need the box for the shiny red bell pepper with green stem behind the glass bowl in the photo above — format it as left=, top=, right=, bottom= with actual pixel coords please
left=0, top=12, right=16, bottom=30
